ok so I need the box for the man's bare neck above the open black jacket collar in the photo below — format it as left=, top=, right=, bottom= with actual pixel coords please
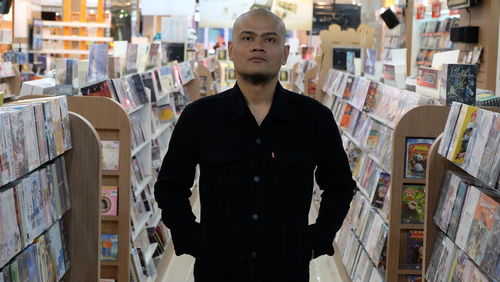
left=238, top=76, right=278, bottom=107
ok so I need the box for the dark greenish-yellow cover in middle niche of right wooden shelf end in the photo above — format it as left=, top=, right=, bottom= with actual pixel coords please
left=401, top=184, right=425, bottom=224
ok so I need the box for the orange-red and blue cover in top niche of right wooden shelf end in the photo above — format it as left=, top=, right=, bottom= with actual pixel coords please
left=405, top=138, right=434, bottom=178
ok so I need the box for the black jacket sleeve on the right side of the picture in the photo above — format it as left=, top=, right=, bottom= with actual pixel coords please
left=309, top=110, right=356, bottom=258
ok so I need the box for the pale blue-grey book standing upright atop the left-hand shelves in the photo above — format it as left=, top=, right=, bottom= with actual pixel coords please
left=87, top=43, right=109, bottom=83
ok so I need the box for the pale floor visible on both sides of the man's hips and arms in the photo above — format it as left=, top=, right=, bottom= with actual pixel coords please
left=162, top=197, right=344, bottom=282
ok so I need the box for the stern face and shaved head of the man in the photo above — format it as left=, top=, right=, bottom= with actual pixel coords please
left=228, top=15, right=290, bottom=83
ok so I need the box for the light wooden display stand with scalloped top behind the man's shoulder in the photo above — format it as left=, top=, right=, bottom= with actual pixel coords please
left=316, top=24, right=375, bottom=101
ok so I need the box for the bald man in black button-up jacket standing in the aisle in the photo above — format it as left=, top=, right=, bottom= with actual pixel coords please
left=155, top=9, right=355, bottom=282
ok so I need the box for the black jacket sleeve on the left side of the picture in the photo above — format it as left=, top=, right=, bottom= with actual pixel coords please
left=154, top=104, right=201, bottom=256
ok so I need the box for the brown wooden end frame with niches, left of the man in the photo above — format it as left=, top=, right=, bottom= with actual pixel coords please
left=68, top=96, right=131, bottom=282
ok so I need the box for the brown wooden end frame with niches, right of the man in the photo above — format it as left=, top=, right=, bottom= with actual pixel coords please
left=386, top=105, right=449, bottom=281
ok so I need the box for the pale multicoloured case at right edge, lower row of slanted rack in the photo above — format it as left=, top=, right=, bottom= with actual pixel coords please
left=466, top=193, right=499, bottom=264
